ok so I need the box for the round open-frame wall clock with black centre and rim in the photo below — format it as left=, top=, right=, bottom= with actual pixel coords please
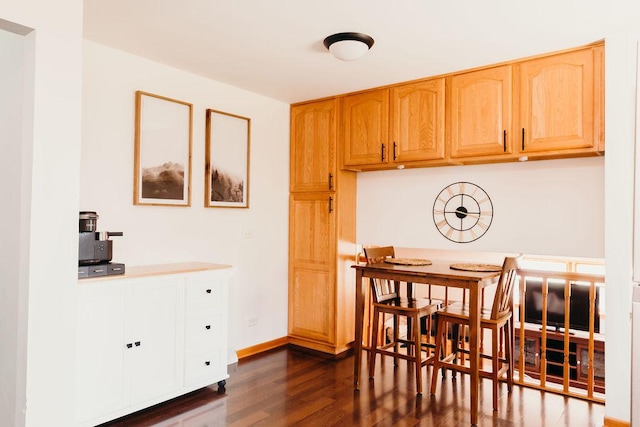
left=433, top=182, right=493, bottom=243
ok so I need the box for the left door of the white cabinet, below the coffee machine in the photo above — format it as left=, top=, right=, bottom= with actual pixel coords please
left=75, top=281, right=127, bottom=421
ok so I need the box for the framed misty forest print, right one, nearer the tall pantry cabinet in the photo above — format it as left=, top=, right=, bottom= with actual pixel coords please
left=204, top=109, right=251, bottom=208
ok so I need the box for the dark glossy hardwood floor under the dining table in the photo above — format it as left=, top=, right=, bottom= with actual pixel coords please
left=104, top=348, right=604, bottom=427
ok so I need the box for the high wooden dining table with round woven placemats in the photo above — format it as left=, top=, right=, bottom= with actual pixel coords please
left=353, top=260, right=500, bottom=425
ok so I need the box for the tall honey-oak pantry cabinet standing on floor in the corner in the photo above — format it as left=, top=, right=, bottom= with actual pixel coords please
left=289, top=98, right=356, bottom=356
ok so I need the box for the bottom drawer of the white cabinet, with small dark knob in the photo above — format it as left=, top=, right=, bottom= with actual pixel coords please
left=184, top=345, right=228, bottom=384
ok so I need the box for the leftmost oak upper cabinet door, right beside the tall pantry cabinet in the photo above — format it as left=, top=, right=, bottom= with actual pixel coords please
left=341, top=89, right=389, bottom=167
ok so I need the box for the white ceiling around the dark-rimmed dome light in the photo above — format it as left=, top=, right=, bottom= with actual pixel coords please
left=84, top=0, right=640, bottom=103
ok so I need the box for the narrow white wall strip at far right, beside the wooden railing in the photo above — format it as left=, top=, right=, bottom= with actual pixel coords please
left=605, top=35, right=638, bottom=420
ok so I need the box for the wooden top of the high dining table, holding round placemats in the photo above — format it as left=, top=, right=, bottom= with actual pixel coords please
left=352, top=259, right=500, bottom=287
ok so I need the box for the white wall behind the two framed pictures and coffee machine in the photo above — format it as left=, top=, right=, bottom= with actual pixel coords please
left=80, top=41, right=289, bottom=349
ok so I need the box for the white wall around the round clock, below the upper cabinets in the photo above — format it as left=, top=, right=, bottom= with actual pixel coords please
left=357, top=157, right=604, bottom=258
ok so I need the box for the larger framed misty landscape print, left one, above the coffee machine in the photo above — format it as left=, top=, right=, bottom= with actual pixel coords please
left=133, top=91, right=193, bottom=206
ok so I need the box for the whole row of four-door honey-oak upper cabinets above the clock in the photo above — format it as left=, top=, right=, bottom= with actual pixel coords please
left=337, top=43, right=604, bottom=171
